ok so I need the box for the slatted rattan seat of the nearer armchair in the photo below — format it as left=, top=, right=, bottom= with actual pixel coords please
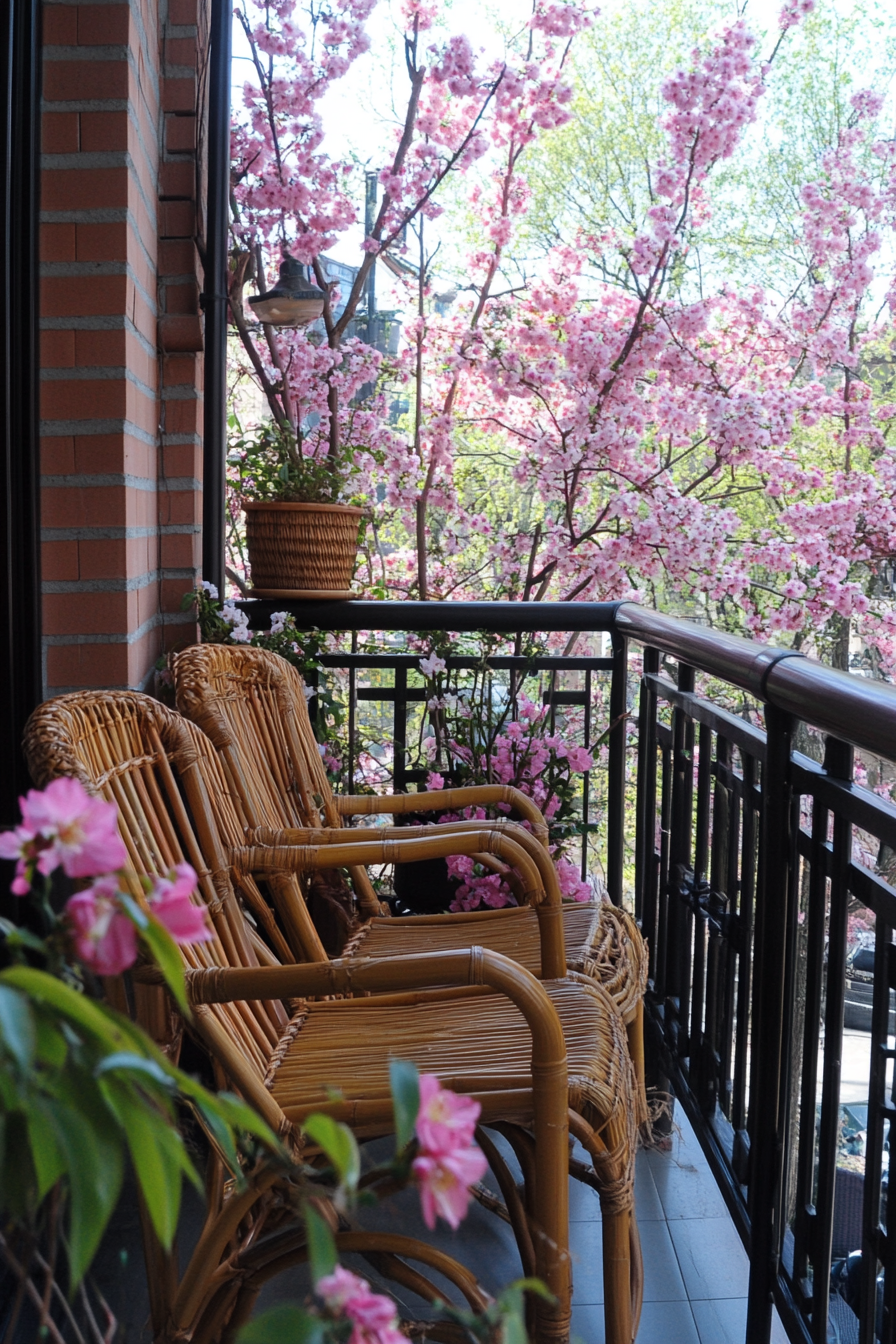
left=266, top=976, right=635, bottom=1180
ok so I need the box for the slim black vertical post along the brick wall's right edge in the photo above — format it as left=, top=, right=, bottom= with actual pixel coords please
left=203, top=0, right=232, bottom=593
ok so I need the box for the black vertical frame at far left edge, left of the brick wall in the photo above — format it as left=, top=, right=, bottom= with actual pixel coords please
left=0, top=0, right=43, bottom=827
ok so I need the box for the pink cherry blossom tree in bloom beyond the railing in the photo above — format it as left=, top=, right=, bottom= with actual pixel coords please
left=231, top=0, right=896, bottom=675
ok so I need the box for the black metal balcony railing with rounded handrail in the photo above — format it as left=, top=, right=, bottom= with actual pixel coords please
left=249, top=602, right=896, bottom=1344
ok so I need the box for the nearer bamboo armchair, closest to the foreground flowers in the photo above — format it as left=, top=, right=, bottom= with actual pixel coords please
left=26, top=692, right=642, bottom=1344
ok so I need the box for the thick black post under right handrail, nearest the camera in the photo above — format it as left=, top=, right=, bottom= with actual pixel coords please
left=746, top=704, right=794, bottom=1344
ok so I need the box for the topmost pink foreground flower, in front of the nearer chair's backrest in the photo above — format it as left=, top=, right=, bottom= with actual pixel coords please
left=9, top=778, right=128, bottom=895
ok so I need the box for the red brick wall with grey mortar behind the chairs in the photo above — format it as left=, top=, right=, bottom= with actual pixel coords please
left=40, top=0, right=206, bottom=695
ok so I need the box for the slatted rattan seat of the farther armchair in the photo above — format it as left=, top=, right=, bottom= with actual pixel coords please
left=343, top=900, right=647, bottom=1021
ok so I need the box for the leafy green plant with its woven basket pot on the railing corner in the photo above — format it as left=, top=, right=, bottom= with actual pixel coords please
left=228, top=417, right=364, bottom=598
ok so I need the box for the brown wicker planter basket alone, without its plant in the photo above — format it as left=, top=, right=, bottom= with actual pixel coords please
left=243, top=501, right=364, bottom=591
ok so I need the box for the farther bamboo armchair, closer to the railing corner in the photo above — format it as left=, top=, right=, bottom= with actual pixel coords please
left=171, top=644, right=647, bottom=1124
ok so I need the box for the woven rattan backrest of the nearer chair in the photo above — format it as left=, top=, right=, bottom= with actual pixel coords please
left=24, top=691, right=289, bottom=1128
